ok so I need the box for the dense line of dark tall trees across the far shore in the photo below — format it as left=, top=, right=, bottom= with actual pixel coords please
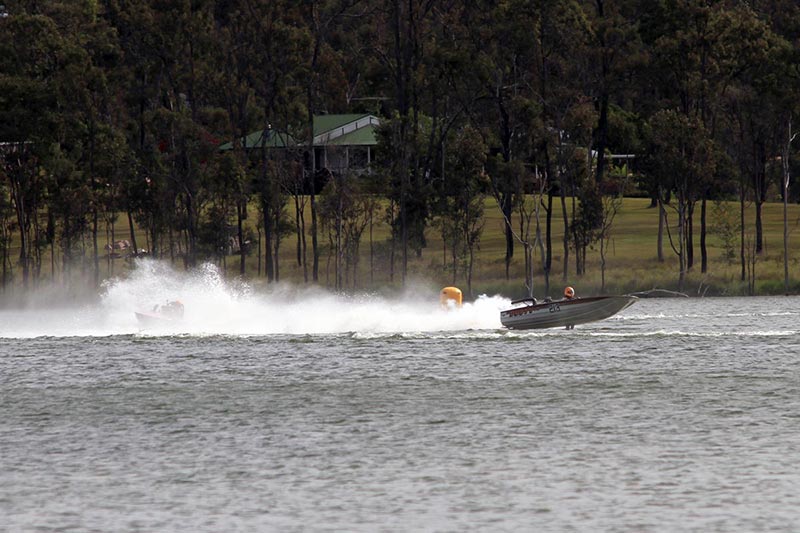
left=0, top=0, right=800, bottom=292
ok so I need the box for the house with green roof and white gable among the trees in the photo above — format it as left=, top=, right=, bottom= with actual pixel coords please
left=219, top=114, right=380, bottom=178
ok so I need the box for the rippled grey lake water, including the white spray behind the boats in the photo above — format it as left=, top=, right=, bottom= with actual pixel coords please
left=0, top=264, right=800, bottom=532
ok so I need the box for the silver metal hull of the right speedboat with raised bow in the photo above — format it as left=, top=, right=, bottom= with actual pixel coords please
left=500, top=296, right=637, bottom=329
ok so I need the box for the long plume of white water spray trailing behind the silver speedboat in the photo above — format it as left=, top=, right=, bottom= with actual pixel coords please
left=0, top=260, right=509, bottom=338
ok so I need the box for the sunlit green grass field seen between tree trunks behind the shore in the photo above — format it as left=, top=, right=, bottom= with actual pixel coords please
left=1, top=198, right=800, bottom=297
